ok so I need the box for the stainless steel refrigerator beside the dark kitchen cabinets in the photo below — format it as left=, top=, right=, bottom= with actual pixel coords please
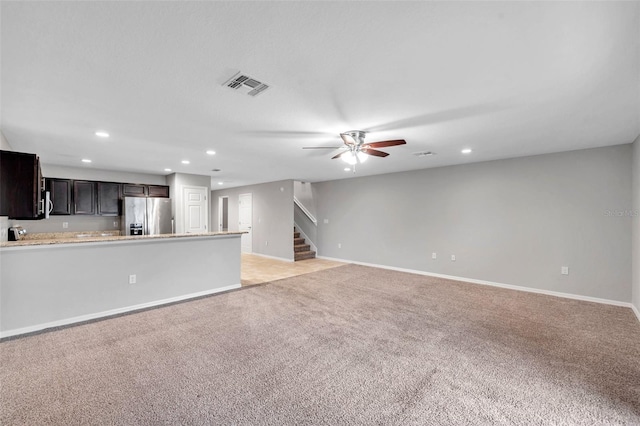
left=121, top=197, right=173, bottom=235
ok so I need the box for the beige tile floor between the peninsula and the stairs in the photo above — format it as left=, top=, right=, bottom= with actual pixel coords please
left=240, top=253, right=346, bottom=286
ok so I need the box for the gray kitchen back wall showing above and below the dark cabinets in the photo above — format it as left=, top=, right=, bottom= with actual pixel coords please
left=9, top=164, right=167, bottom=233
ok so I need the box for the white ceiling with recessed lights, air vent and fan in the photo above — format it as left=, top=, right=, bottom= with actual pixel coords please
left=0, top=1, right=640, bottom=186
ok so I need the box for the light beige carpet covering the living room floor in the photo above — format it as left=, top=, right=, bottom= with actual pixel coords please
left=0, top=265, right=640, bottom=425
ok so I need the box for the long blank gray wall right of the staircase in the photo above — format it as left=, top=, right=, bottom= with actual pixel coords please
left=314, top=145, right=632, bottom=302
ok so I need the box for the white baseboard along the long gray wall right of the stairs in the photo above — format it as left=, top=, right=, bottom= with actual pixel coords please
left=317, top=256, right=640, bottom=310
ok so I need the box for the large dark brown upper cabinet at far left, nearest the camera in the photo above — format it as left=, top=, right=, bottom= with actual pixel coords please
left=0, top=151, right=42, bottom=219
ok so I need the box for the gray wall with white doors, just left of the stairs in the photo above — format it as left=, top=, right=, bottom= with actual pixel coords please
left=211, top=180, right=293, bottom=260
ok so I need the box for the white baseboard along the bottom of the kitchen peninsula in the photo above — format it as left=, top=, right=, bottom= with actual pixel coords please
left=0, top=284, right=240, bottom=339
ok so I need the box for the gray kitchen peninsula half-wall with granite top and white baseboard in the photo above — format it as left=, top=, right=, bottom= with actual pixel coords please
left=0, top=232, right=242, bottom=337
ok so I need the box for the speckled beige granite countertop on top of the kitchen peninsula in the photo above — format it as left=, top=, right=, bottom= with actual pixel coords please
left=0, top=231, right=244, bottom=248
